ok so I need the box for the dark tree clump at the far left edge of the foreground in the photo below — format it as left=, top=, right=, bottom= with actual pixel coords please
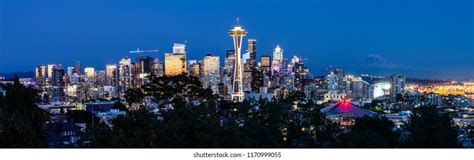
left=0, top=78, right=49, bottom=148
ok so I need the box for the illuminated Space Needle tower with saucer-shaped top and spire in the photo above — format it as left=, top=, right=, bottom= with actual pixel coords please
left=229, top=18, right=247, bottom=102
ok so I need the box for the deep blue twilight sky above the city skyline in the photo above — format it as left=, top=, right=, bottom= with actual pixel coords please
left=0, top=0, right=474, bottom=78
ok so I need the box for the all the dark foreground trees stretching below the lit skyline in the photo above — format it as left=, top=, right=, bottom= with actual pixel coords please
left=0, top=76, right=460, bottom=148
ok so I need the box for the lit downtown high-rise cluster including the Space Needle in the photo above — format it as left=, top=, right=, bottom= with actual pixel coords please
left=35, top=23, right=318, bottom=102
